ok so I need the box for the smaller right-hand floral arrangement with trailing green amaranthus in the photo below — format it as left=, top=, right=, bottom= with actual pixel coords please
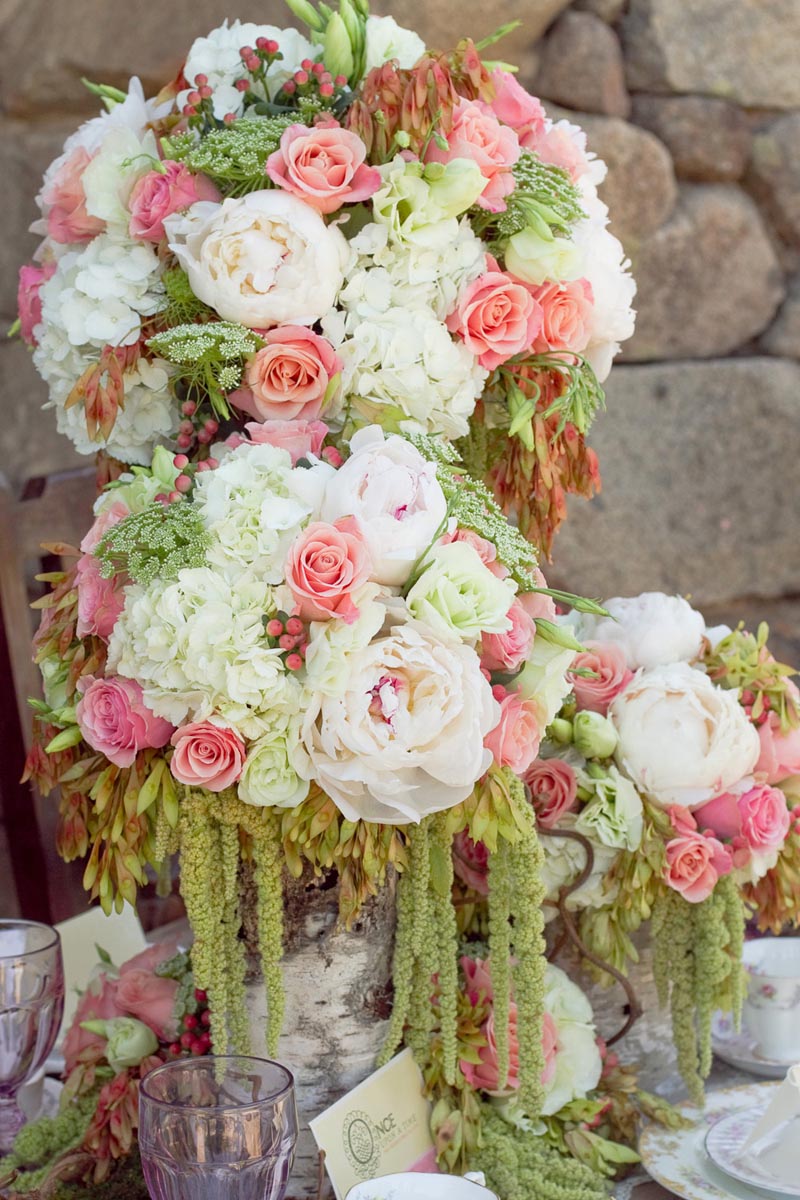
left=455, top=593, right=800, bottom=1099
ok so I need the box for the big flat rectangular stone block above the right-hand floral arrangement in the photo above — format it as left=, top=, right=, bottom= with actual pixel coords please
left=548, top=358, right=800, bottom=605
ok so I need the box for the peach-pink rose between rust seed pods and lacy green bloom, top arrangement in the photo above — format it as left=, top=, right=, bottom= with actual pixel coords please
left=427, top=100, right=521, bottom=212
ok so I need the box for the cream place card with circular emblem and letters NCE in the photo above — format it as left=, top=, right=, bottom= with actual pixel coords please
left=309, top=1050, right=435, bottom=1200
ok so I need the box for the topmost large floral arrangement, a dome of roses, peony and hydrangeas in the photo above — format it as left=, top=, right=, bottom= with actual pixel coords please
left=14, top=0, right=634, bottom=550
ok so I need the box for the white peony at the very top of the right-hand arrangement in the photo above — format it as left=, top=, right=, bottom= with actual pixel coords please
left=578, top=592, right=705, bottom=671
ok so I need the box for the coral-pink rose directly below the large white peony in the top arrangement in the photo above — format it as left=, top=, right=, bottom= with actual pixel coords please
left=229, top=325, right=342, bottom=421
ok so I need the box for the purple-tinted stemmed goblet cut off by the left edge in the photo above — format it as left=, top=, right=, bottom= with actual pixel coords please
left=0, top=920, right=64, bottom=1153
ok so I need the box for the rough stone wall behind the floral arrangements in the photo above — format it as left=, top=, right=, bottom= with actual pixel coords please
left=0, top=0, right=800, bottom=659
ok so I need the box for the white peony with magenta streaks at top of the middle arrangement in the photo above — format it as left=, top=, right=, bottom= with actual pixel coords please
left=320, top=425, right=447, bottom=587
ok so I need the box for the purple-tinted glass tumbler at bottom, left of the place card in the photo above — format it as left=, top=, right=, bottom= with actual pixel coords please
left=139, top=1056, right=297, bottom=1200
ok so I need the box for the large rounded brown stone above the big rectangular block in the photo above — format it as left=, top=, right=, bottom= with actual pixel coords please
left=624, top=184, right=784, bottom=361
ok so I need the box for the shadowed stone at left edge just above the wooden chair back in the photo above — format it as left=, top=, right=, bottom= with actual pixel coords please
left=0, top=338, right=84, bottom=486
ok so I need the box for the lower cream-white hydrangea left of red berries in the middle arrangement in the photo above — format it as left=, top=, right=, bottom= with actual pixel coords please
left=108, top=566, right=293, bottom=738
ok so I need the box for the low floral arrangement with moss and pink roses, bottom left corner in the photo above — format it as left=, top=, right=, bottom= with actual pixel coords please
left=2, top=943, right=196, bottom=1200
